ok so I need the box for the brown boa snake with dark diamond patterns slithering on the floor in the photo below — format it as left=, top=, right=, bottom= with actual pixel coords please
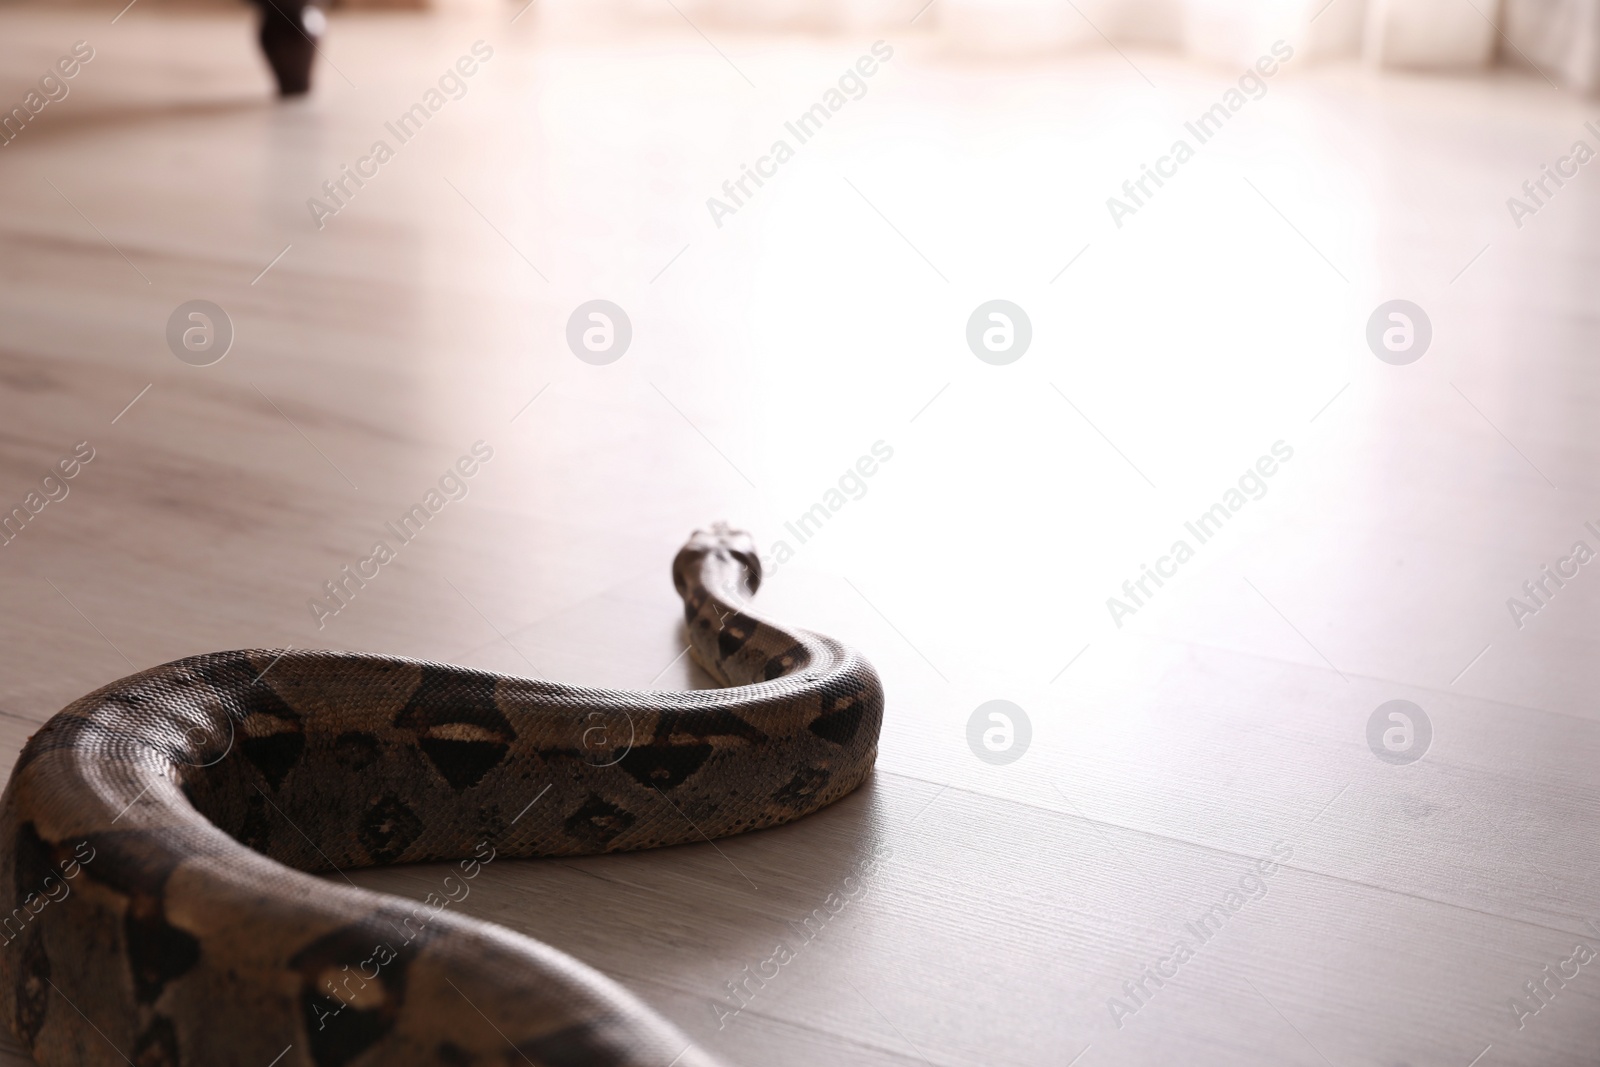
left=0, top=526, right=883, bottom=1067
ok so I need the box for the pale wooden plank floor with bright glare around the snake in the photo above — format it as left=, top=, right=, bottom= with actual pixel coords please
left=0, top=2, right=1600, bottom=1067
